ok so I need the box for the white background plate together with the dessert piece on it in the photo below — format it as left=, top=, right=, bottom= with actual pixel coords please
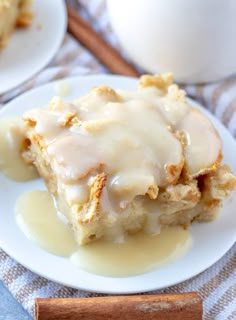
left=0, top=0, right=67, bottom=95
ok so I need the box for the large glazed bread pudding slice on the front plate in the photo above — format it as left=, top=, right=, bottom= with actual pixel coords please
left=23, top=74, right=236, bottom=245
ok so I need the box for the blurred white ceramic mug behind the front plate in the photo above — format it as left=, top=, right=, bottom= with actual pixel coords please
left=107, top=0, right=236, bottom=83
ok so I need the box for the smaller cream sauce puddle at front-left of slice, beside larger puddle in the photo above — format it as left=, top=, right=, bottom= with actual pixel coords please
left=16, top=190, right=77, bottom=256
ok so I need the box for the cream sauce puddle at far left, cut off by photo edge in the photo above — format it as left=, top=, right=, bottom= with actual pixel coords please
left=0, top=119, right=38, bottom=181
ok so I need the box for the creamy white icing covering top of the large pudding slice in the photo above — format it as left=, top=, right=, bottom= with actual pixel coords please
left=23, top=85, right=221, bottom=212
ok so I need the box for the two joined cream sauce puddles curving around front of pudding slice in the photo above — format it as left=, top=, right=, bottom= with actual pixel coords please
left=16, top=191, right=192, bottom=277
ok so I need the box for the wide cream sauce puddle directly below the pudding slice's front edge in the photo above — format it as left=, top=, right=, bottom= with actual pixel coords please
left=71, top=226, right=192, bottom=277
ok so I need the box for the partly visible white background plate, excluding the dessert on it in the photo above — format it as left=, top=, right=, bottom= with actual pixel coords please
left=0, top=0, right=67, bottom=94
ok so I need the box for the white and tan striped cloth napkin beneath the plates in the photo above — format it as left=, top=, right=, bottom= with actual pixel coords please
left=0, top=0, right=236, bottom=320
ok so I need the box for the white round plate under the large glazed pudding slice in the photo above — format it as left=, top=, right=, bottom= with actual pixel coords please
left=0, top=75, right=236, bottom=294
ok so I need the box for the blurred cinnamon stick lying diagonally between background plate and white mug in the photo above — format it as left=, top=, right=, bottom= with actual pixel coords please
left=67, top=5, right=139, bottom=77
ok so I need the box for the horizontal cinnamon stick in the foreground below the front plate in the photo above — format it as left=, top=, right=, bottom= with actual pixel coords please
left=35, top=292, right=202, bottom=320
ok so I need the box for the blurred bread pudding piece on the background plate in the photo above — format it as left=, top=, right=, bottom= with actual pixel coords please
left=0, top=0, right=32, bottom=48
